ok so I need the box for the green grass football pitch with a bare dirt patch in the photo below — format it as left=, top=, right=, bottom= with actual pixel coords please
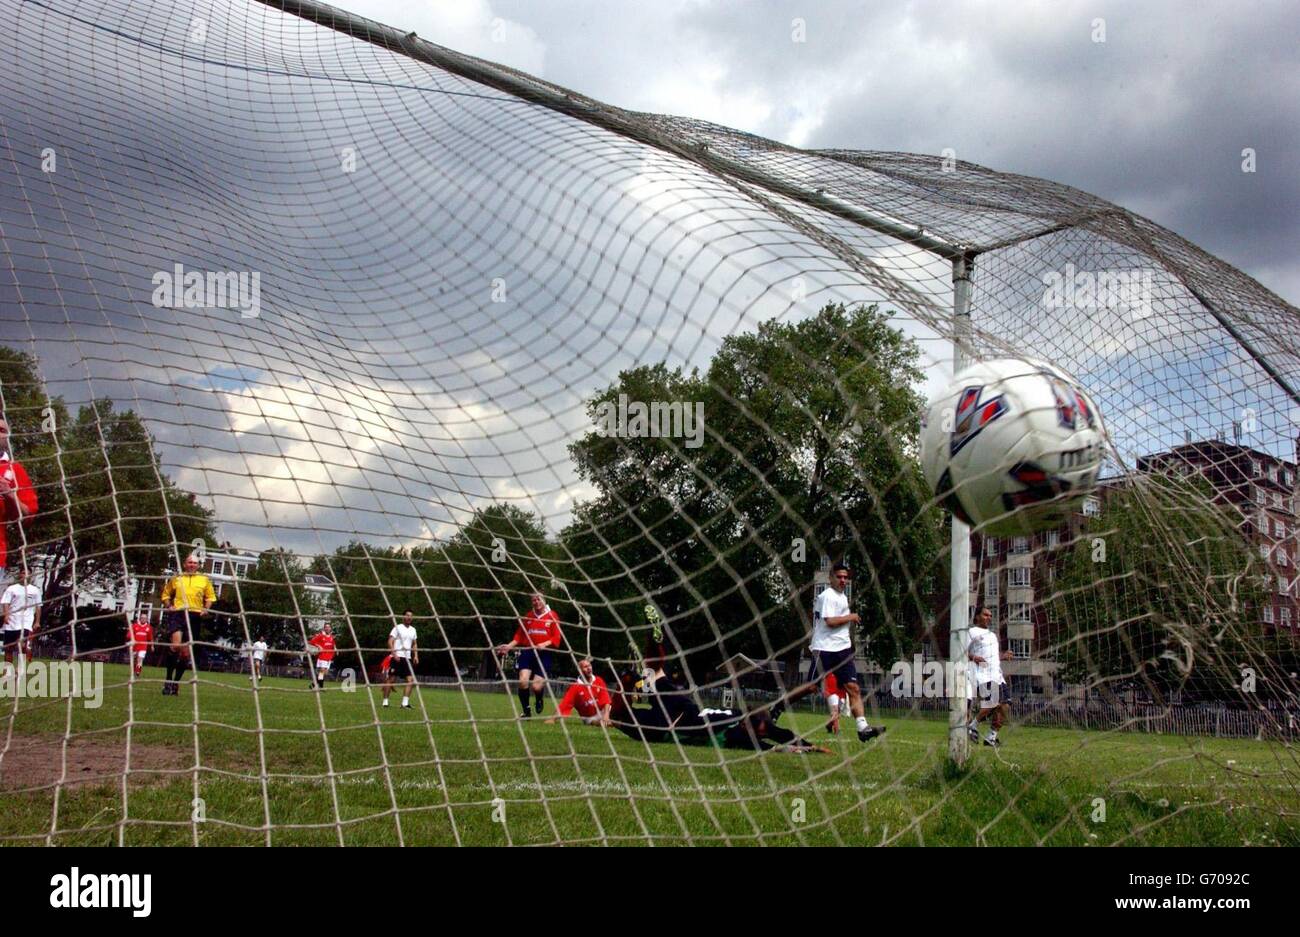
left=0, top=665, right=1300, bottom=846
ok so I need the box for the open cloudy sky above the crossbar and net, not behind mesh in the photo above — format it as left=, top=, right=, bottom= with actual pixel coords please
left=338, top=0, right=1300, bottom=304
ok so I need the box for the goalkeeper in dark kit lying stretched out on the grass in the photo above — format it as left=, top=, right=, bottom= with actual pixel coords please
left=610, top=673, right=831, bottom=754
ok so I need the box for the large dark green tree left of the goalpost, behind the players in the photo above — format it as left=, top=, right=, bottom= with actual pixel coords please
left=562, top=305, right=941, bottom=678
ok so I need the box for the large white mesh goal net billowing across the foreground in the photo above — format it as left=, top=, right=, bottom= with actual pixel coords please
left=0, top=0, right=1300, bottom=845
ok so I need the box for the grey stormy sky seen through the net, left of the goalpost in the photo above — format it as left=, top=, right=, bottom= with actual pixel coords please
left=0, top=0, right=883, bottom=552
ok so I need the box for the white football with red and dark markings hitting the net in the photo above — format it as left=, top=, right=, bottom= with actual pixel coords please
left=920, top=357, right=1105, bottom=535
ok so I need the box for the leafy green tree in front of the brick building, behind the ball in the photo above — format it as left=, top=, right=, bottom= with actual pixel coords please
left=1047, top=473, right=1268, bottom=699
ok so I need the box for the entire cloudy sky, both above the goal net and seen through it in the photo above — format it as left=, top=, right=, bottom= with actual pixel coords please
left=0, top=0, right=1300, bottom=564
